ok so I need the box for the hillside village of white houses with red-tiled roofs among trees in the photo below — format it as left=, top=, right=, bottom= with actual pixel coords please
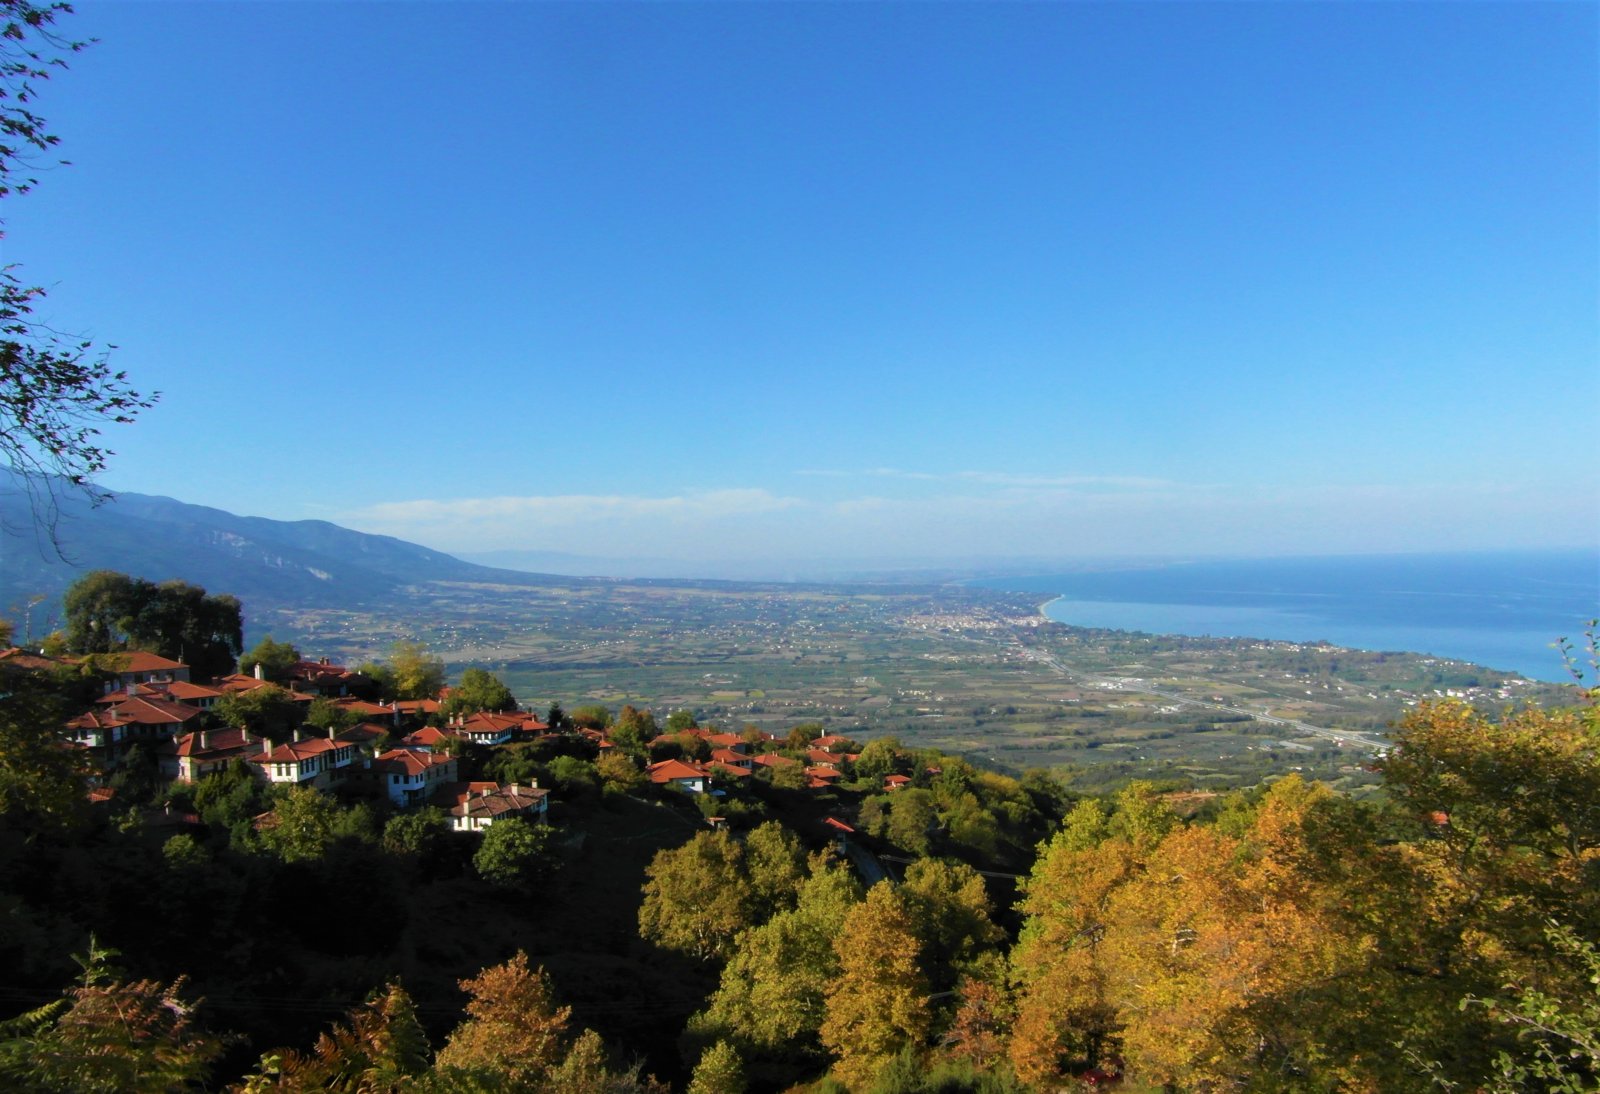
left=0, top=648, right=912, bottom=832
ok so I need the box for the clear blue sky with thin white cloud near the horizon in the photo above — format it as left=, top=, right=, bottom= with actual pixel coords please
left=0, top=3, right=1600, bottom=573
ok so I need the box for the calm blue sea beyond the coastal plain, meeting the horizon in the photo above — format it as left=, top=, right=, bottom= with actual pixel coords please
left=973, top=550, right=1600, bottom=681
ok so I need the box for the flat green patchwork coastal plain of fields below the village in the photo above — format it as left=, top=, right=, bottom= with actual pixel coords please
left=256, top=577, right=1578, bottom=792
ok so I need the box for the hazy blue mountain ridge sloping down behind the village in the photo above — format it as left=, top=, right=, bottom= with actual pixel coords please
left=0, top=475, right=573, bottom=630
